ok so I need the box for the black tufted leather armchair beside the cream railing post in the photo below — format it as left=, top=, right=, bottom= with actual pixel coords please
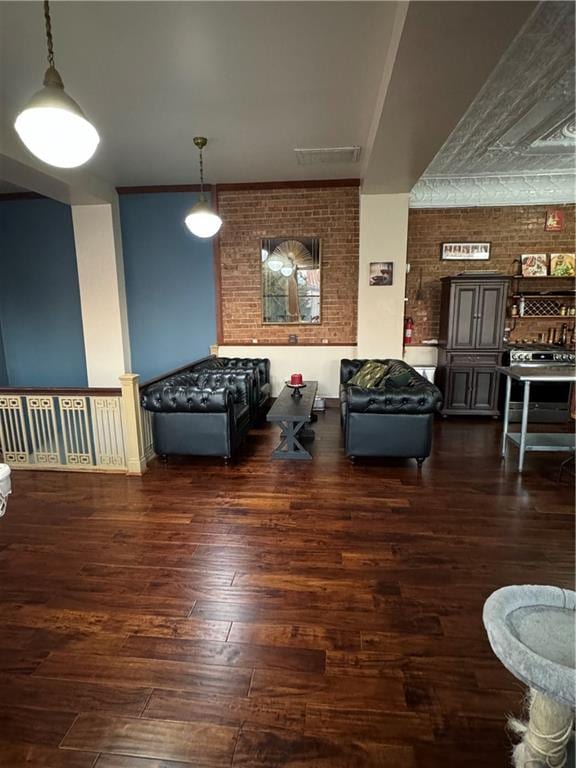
left=141, top=370, right=254, bottom=459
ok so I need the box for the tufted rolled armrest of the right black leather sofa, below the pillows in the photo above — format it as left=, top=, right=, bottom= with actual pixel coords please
left=346, top=379, right=442, bottom=413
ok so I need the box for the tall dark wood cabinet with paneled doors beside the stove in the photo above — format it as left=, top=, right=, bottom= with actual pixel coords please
left=438, top=275, right=509, bottom=416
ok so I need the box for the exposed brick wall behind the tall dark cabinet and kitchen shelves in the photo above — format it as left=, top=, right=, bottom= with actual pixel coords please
left=406, top=205, right=575, bottom=344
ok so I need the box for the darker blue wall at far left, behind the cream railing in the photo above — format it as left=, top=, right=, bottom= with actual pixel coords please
left=0, top=198, right=87, bottom=387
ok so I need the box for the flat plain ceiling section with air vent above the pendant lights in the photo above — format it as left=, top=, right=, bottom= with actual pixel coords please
left=0, top=2, right=397, bottom=186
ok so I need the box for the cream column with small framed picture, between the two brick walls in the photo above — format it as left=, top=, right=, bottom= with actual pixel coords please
left=357, top=194, right=410, bottom=359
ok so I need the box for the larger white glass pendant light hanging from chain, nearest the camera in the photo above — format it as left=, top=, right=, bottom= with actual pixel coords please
left=14, top=0, right=100, bottom=168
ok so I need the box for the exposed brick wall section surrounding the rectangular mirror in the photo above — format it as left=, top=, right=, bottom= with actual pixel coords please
left=218, top=187, right=359, bottom=344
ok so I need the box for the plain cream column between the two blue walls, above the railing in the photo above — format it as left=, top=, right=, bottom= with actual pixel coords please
left=72, top=199, right=131, bottom=387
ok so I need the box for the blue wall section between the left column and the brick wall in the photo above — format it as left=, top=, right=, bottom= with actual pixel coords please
left=120, top=192, right=216, bottom=381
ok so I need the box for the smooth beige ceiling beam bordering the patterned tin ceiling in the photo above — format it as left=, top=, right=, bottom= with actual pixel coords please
left=363, top=0, right=536, bottom=193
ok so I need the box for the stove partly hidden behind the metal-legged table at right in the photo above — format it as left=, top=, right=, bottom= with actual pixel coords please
left=503, top=342, right=576, bottom=424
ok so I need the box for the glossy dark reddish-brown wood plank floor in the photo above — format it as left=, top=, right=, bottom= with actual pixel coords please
left=0, top=411, right=573, bottom=768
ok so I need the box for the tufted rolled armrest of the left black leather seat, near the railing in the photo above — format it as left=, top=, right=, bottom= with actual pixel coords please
left=140, top=383, right=234, bottom=413
